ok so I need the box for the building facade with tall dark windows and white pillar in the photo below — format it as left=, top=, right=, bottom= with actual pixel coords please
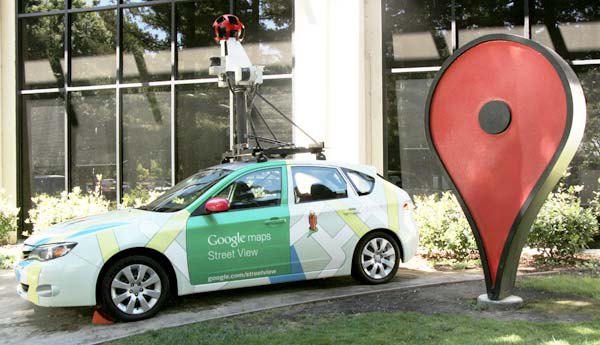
left=0, top=0, right=600, bottom=236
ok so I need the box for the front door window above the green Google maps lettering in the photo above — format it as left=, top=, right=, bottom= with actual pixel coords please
left=216, top=168, right=281, bottom=210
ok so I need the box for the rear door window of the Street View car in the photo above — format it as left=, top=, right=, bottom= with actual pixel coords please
left=292, top=167, right=348, bottom=204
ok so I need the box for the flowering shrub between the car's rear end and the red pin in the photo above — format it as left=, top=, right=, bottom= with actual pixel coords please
left=415, top=192, right=477, bottom=260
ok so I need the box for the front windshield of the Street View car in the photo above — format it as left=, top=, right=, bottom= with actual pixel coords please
left=139, top=168, right=231, bottom=212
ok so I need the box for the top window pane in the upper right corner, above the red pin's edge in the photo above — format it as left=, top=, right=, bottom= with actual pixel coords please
left=531, top=0, right=600, bottom=60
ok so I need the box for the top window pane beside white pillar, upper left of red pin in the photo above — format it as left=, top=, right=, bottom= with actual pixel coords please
left=383, top=0, right=452, bottom=67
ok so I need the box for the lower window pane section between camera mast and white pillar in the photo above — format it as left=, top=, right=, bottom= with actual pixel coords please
left=249, top=79, right=292, bottom=147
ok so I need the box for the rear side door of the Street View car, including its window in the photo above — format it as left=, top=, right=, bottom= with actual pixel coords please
left=288, top=166, right=358, bottom=279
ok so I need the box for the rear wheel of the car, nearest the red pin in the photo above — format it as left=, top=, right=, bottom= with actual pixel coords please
left=352, top=231, right=400, bottom=284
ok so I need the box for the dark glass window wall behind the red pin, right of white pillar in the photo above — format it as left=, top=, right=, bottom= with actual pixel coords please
left=383, top=0, right=600, bottom=198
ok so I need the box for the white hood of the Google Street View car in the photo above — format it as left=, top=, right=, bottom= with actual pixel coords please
left=25, top=208, right=149, bottom=246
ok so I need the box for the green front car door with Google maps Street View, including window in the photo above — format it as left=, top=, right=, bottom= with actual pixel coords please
left=187, top=166, right=291, bottom=285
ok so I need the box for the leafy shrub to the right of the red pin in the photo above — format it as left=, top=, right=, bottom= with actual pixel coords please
left=528, top=183, right=598, bottom=261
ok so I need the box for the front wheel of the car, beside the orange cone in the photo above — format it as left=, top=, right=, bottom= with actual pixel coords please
left=100, top=255, right=170, bottom=322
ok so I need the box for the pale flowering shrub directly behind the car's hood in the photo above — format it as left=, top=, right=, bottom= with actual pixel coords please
left=26, top=187, right=111, bottom=233
